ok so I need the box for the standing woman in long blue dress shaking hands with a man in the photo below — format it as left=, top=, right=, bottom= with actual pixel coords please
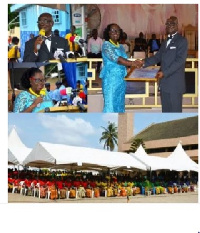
left=100, top=24, right=140, bottom=112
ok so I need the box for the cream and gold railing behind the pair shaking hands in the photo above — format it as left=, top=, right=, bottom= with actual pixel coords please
left=87, top=58, right=198, bottom=109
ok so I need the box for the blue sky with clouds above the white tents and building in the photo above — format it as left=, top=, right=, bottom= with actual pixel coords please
left=8, top=113, right=197, bottom=149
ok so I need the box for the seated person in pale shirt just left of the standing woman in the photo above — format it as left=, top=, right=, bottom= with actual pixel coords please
left=87, top=29, right=103, bottom=73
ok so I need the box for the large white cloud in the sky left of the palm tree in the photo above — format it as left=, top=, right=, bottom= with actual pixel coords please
left=39, top=114, right=95, bottom=146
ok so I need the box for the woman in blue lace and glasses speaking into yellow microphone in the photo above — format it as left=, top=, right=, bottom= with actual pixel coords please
left=13, top=68, right=53, bottom=113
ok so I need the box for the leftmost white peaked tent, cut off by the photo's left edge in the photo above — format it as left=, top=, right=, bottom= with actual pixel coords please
left=8, top=127, right=32, bottom=164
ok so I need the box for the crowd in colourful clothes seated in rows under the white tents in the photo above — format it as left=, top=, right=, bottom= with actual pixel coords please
left=8, top=169, right=197, bottom=199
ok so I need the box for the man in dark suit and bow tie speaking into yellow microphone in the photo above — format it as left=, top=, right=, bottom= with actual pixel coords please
left=23, top=13, right=69, bottom=62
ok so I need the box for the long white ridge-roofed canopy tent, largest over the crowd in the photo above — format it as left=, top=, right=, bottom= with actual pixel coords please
left=23, top=142, right=146, bottom=170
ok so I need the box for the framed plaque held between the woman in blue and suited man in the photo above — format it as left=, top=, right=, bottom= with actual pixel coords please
left=126, top=66, right=160, bottom=81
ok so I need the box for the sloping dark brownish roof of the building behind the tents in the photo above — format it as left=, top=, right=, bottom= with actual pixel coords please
left=128, top=116, right=198, bottom=143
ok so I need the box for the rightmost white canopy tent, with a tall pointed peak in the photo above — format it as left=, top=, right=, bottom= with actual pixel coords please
left=167, top=142, right=199, bottom=172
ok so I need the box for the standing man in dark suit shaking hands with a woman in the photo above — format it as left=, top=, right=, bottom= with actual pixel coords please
left=142, top=16, right=188, bottom=112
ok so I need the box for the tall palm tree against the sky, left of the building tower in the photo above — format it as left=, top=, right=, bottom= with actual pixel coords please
left=99, top=122, right=118, bottom=151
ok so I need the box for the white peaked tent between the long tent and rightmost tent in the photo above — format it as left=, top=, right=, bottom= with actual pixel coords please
left=130, top=145, right=172, bottom=171
